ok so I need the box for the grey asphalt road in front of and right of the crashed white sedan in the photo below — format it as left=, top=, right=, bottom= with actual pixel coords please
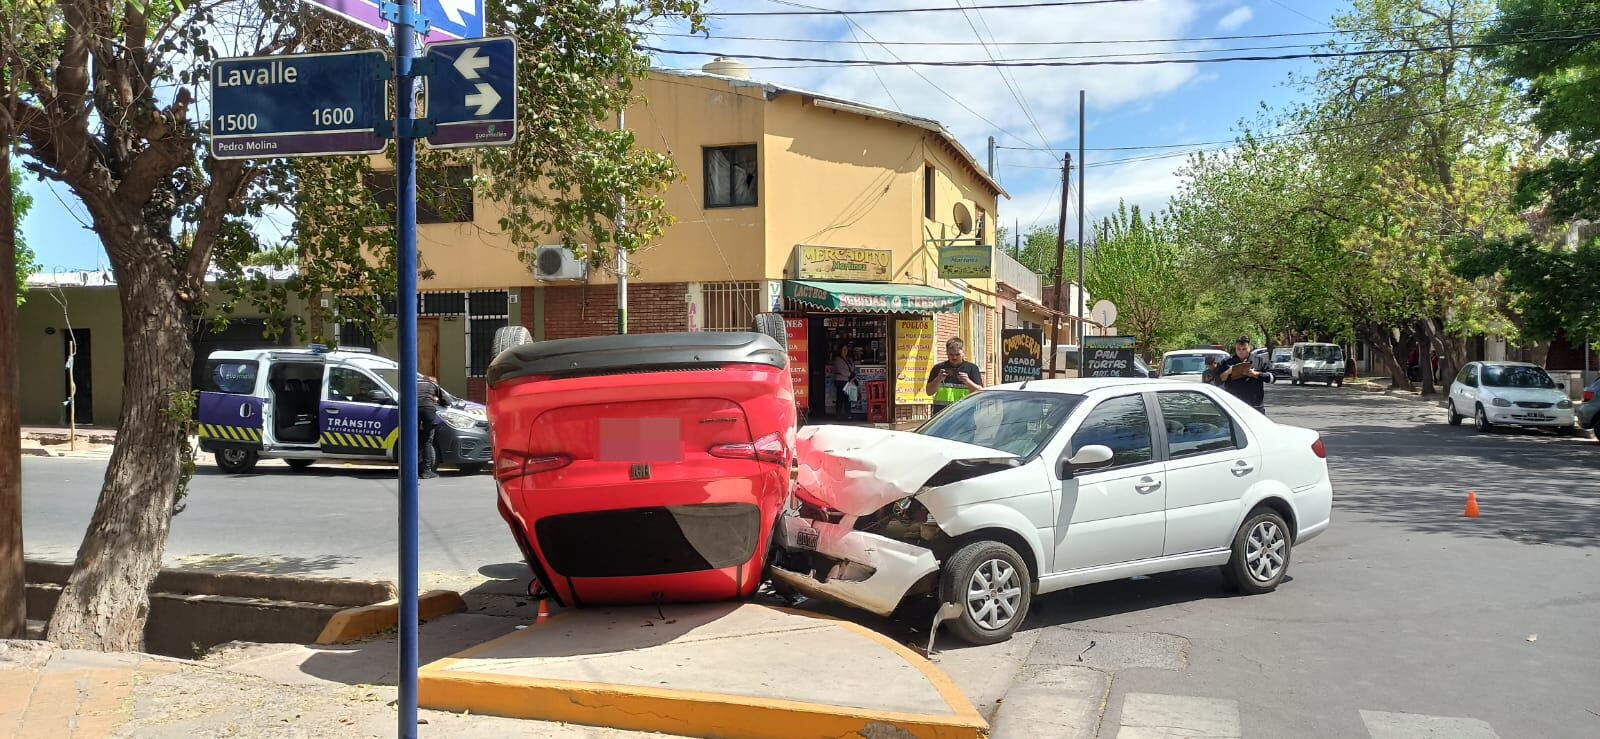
left=944, top=385, right=1600, bottom=737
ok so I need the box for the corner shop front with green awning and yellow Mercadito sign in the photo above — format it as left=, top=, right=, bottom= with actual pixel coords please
left=784, top=246, right=963, bottom=424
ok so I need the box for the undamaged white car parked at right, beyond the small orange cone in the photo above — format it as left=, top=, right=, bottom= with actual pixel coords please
left=1445, top=362, right=1578, bottom=433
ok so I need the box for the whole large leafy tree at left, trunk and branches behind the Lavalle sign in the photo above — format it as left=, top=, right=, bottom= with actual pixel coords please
left=0, top=0, right=699, bottom=649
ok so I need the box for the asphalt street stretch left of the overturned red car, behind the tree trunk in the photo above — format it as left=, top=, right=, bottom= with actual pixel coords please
left=22, top=454, right=522, bottom=587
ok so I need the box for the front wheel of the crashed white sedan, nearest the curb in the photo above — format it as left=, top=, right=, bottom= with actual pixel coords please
left=939, top=541, right=1034, bottom=645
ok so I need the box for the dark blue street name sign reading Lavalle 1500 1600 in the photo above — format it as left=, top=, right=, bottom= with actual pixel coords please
left=211, top=51, right=389, bottom=158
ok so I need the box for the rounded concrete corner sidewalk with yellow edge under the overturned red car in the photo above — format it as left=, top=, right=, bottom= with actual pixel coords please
left=418, top=603, right=987, bottom=739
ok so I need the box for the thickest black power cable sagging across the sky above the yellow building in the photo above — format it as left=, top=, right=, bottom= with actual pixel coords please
left=638, top=32, right=1600, bottom=69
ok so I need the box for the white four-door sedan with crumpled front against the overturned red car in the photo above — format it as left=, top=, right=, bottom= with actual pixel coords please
left=771, top=379, right=1333, bottom=643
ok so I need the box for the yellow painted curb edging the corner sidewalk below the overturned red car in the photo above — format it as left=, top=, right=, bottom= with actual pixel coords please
left=418, top=606, right=989, bottom=739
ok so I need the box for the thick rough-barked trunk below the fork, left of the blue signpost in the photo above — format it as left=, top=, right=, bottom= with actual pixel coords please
left=48, top=257, right=194, bottom=651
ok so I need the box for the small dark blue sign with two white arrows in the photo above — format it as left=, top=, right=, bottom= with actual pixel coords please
left=427, top=38, right=517, bottom=149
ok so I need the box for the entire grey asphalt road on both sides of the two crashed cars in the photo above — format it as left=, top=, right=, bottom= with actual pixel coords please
left=24, top=385, right=1600, bottom=737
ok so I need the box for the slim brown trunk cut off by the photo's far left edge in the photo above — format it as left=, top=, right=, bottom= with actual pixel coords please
left=0, top=147, right=27, bottom=638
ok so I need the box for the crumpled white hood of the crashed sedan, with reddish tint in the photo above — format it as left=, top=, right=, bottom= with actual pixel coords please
left=795, top=425, right=1016, bottom=515
